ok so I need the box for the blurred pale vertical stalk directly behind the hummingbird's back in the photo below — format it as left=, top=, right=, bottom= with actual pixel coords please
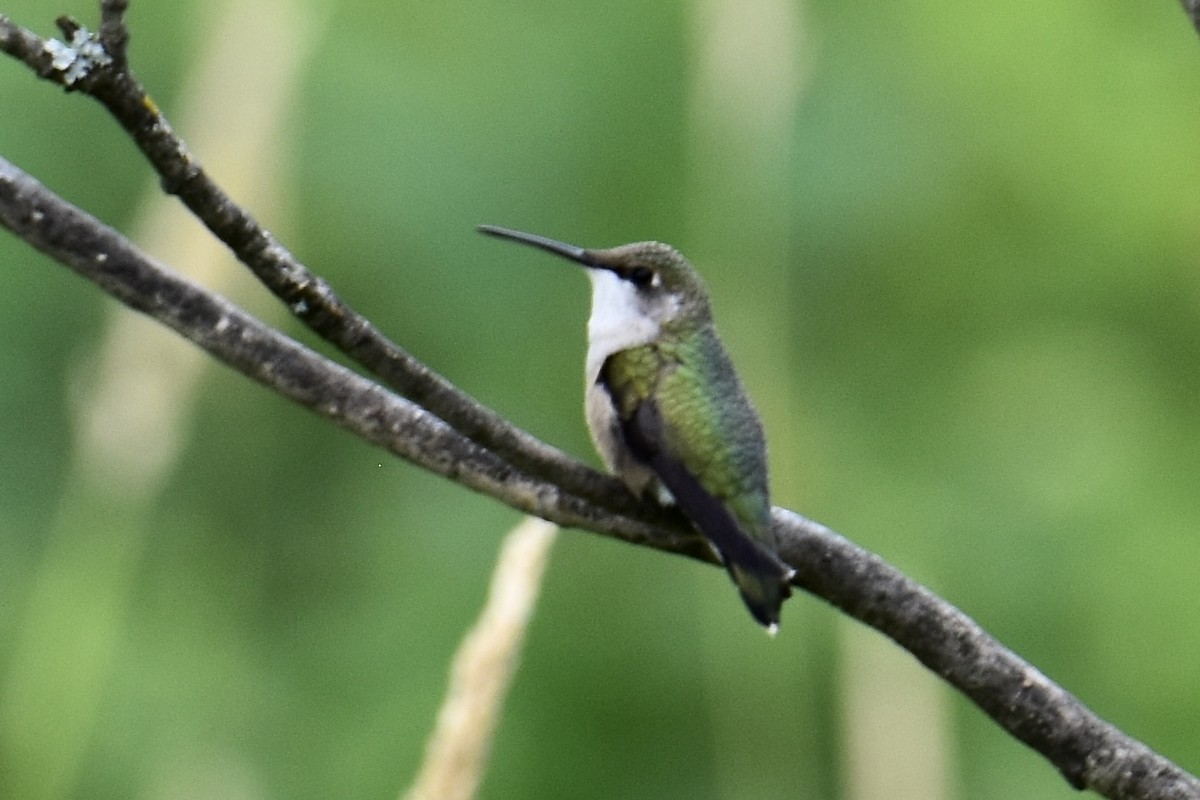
left=691, top=0, right=809, bottom=796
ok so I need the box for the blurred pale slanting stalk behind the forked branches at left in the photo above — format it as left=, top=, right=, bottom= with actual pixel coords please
left=0, top=0, right=313, bottom=800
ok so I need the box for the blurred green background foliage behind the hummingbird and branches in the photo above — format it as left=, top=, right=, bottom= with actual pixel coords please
left=0, top=0, right=1200, bottom=800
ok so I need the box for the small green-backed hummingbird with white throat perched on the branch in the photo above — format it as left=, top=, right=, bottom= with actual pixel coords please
left=479, top=225, right=794, bottom=634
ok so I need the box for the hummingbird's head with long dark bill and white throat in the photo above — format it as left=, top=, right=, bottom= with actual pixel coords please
left=479, top=225, right=712, bottom=339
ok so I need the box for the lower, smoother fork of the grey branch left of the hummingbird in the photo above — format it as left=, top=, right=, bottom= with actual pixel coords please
left=0, top=158, right=691, bottom=558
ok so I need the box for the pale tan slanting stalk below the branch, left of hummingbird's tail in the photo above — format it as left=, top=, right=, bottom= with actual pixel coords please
left=403, top=517, right=558, bottom=800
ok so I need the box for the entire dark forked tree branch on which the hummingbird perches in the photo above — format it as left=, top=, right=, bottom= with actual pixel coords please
left=0, top=6, right=1200, bottom=800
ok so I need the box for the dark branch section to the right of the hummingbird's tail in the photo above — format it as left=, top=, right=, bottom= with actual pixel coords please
left=774, top=509, right=1200, bottom=800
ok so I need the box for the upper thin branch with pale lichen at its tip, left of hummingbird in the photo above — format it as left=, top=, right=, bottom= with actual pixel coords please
left=0, top=9, right=644, bottom=522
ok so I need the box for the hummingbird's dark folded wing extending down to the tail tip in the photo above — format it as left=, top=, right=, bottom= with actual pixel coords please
left=620, top=398, right=792, bottom=631
